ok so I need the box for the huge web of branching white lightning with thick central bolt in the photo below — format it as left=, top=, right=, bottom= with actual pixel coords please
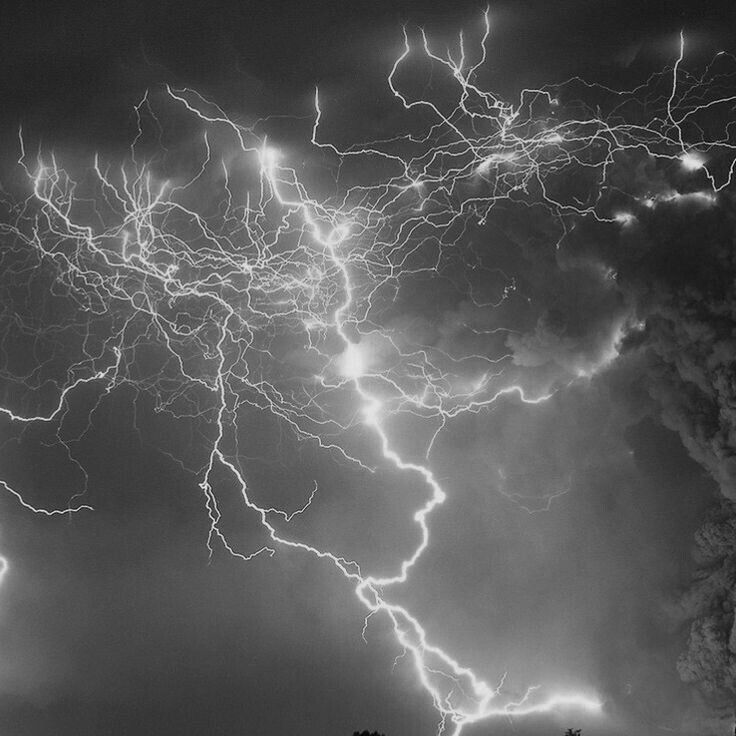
left=0, top=13, right=736, bottom=736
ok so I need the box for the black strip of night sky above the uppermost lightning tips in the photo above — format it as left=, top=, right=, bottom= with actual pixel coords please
left=0, top=0, right=734, bottom=145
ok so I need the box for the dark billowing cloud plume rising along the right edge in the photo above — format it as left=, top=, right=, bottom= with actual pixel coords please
left=478, top=154, right=736, bottom=720
